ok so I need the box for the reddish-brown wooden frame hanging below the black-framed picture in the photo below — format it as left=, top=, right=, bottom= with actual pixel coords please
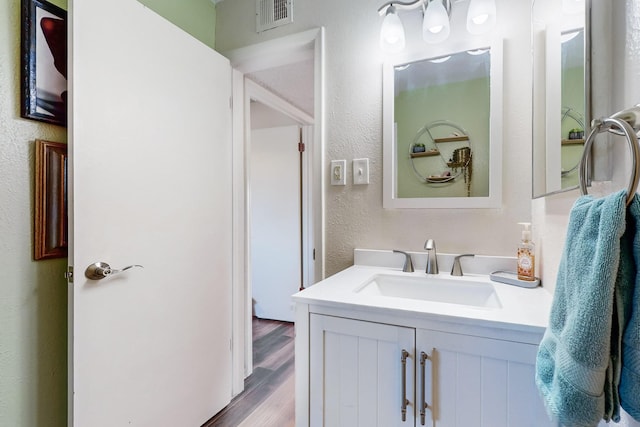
left=34, top=139, right=68, bottom=260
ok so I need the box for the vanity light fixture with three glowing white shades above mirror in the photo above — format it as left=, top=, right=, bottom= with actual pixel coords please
left=378, top=0, right=496, bottom=53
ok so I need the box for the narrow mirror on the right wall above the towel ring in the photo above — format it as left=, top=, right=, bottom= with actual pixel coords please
left=531, top=0, right=590, bottom=198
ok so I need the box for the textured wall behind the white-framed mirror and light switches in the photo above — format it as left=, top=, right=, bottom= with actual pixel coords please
left=216, top=0, right=531, bottom=275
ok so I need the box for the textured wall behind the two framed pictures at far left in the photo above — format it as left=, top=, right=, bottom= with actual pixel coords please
left=0, top=0, right=67, bottom=427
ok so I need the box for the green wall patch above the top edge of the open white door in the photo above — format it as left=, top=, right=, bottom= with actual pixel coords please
left=138, top=0, right=216, bottom=48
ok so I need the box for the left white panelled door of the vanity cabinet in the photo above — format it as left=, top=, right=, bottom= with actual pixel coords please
left=309, top=314, right=415, bottom=427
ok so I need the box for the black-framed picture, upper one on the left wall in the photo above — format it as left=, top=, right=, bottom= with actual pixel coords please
left=20, top=0, right=67, bottom=126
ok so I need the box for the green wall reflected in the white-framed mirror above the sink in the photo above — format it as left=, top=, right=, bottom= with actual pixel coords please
left=395, top=77, right=489, bottom=198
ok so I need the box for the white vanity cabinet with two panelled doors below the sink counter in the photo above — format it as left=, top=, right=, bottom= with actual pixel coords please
left=296, top=312, right=553, bottom=427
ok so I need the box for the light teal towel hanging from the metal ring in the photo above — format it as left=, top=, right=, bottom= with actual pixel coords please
left=536, top=191, right=628, bottom=426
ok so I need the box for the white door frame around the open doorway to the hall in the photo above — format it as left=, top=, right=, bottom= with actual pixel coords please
left=225, top=27, right=325, bottom=396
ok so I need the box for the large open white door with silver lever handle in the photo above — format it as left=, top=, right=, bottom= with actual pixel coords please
left=69, top=0, right=231, bottom=427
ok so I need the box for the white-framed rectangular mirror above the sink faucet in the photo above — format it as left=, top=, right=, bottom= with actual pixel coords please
left=383, top=41, right=502, bottom=208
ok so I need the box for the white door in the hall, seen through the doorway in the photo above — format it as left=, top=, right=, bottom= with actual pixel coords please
left=250, top=126, right=302, bottom=322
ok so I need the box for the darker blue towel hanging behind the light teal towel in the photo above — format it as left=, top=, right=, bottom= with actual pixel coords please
left=619, top=195, right=640, bottom=421
